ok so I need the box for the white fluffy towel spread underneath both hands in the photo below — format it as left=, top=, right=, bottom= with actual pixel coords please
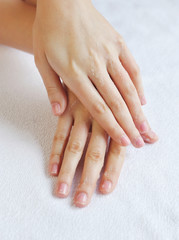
left=0, top=0, right=179, bottom=240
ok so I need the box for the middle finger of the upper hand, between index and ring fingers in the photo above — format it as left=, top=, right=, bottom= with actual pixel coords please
left=89, top=68, right=144, bottom=148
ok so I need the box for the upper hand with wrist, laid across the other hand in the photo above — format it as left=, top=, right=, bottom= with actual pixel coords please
left=33, top=0, right=157, bottom=147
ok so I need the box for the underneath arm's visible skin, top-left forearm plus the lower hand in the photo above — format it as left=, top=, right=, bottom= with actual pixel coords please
left=0, top=0, right=157, bottom=207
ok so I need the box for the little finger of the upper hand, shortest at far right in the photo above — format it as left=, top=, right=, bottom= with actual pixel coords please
left=119, top=44, right=147, bottom=105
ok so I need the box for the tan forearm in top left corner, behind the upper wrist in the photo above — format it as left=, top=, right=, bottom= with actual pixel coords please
left=0, top=0, right=35, bottom=53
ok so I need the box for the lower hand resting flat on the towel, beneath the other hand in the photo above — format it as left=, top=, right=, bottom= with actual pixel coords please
left=49, top=90, right=157, bottom=207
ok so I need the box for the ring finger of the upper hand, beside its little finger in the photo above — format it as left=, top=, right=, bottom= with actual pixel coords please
left=108, top=61, right=158, bottom=143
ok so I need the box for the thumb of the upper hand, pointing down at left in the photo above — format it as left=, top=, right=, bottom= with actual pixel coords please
left=35, top=54, right=67, bottom=116
